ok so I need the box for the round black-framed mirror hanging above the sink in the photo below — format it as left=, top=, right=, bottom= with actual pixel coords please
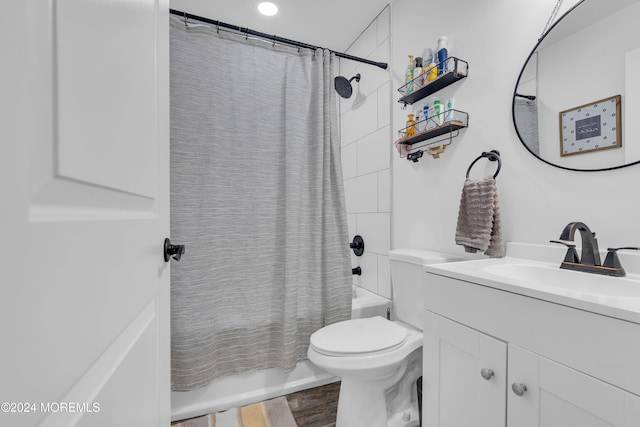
left=512, top=0, right=640, bottom=171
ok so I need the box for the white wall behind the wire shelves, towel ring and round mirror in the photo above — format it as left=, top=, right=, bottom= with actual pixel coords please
left=389, top=0, right=640, bottom=262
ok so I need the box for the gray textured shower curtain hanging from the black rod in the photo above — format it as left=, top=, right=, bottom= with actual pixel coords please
left=170, top=19, right=351, bottom=391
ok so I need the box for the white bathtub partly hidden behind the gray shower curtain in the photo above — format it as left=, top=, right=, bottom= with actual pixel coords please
left=171, top=285, right=391, bottom=421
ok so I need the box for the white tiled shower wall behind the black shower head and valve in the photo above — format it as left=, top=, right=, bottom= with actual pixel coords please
left=340, top=6, right=393, bottom=298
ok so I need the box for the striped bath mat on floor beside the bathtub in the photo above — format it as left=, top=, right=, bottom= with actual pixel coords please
left=171, top=396, right=298, bottom=427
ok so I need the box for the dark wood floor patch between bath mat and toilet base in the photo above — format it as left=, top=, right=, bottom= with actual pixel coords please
left=287, top=382, right=340, bottom=427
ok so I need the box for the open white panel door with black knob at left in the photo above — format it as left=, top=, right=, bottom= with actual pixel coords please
left=0, top=0, right=170, bottom=427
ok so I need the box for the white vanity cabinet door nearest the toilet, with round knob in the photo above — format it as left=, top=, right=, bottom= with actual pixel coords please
left=422, top=311, right=507, bottom=427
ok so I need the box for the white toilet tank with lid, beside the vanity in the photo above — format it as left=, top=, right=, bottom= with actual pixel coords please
left=389, top=249, right=463, bottom=330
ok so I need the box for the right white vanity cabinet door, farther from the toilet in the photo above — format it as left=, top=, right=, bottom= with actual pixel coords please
left=507, top=345, right=640, bottom=427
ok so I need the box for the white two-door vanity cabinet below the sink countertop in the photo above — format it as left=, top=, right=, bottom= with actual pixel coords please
left=422, top=273, right=640, bottom=427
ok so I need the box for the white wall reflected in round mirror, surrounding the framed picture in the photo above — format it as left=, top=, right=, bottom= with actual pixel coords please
left=538, top=4, right=640, bottom=169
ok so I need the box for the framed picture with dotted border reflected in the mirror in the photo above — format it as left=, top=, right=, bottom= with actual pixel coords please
left=559, top=95, right=622, bottom=157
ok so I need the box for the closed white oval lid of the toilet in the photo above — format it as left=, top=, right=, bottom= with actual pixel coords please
left=311, top=316, right=407, bottom=355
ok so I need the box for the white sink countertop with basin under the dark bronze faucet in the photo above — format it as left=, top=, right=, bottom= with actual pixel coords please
left=425, top=244, right=640, bottom=323
